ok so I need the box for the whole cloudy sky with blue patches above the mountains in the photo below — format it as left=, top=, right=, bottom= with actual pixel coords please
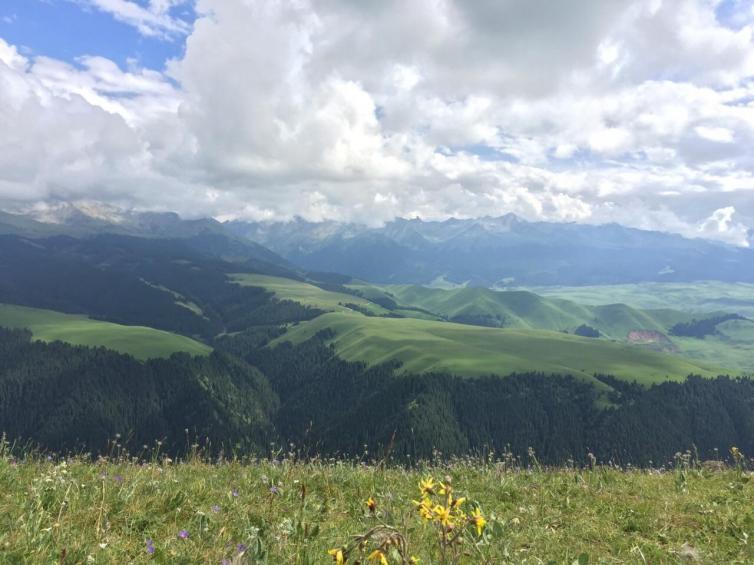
left=0, top=0, right=754, bottom=246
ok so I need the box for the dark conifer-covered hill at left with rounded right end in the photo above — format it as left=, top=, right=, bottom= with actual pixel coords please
left=0, top=329, right=278, bottom=453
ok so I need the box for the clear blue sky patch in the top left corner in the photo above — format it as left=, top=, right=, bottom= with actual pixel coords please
left=0, top=0, right=194, bottom=70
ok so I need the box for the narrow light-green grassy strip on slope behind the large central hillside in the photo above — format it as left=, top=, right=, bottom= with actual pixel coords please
left=231, top=273, right=387, bottom=315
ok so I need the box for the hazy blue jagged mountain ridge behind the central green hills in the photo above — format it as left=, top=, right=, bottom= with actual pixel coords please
left=224, top=214, right=754, bottom=287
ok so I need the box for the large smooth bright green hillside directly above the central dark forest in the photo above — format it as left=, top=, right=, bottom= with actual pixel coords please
left=277, top=312, right=719, bottom=384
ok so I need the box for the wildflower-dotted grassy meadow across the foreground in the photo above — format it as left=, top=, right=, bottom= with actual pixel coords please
left=0, top=454, right=754, bottom=565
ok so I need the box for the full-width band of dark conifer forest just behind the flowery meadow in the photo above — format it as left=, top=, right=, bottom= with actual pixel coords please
left=5, top=327, right=754, bottom=465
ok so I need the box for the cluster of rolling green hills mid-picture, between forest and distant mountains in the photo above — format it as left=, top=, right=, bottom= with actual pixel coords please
left=232, top=275, right=724, bottom=386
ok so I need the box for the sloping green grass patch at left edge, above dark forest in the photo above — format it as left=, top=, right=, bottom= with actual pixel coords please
left=0, top=304, right=212, bottom=359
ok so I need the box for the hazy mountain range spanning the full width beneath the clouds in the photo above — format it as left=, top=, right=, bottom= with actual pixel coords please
left=0, top=205, right=754, bottom=288
